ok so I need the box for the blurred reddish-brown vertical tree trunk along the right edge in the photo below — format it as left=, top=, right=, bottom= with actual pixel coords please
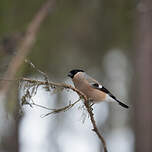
left=134, top=0, right=152, bottom=152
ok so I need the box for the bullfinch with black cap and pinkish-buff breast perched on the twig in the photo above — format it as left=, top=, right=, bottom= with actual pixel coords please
left=68, top=69, right=129, bottom=108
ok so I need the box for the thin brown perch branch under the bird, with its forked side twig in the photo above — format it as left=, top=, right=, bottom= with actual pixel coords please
left=0, top=78, right=108, bottom=152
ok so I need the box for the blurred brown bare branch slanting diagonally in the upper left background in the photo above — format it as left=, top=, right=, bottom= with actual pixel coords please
left=1, top=0, right=55, bottom=95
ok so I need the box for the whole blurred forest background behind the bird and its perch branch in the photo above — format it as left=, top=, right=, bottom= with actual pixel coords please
left=0, top=0, right=152, bottom=152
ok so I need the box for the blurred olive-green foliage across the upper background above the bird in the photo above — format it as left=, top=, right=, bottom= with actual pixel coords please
left=0, top=0, right=134, bottom=78
